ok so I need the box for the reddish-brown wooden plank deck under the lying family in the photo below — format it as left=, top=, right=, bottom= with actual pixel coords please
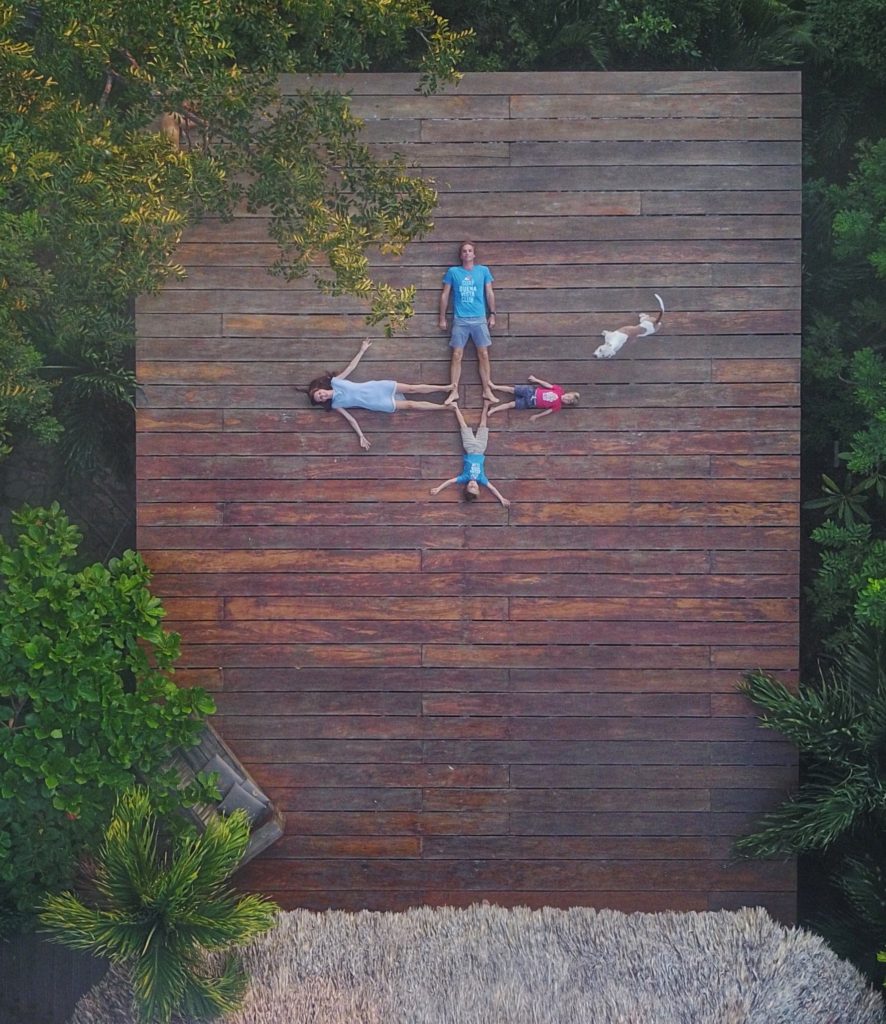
left=133, top=73, right=800, bottom=920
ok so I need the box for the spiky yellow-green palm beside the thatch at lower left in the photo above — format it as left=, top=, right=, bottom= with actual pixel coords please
left=40, top=787, right=278, bottom=1024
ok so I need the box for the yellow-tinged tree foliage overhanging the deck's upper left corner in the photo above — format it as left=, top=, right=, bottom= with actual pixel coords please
left=0, top=0, right=471, bottom=467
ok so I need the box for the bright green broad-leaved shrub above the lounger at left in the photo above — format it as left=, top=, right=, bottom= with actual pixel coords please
left=0, top=506, right=215, bottom=921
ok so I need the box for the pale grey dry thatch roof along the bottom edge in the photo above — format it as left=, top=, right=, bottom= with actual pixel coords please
left=72, top=905, right=883, bottom=1024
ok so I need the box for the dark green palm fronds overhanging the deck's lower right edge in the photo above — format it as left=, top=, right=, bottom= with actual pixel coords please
left=735, top=627, right=886, bottom=977
